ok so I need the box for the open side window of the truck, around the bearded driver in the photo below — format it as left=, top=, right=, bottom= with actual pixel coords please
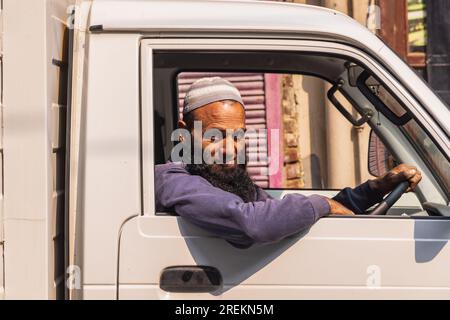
left=147, top=43, right=448, bottom=214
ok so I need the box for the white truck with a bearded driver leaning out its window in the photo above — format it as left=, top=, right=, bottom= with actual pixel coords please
left=0, top=0, right=450, bottom=299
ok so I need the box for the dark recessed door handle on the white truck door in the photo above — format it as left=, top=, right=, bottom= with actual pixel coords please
left=159, top=266, right=223, bottom=293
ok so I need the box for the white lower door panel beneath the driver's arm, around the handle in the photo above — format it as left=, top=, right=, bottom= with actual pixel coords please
left=119, top=216, right=450, bottom=299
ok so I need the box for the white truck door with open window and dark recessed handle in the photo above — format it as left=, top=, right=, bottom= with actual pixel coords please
left=111, top=39, right=450, bottom=299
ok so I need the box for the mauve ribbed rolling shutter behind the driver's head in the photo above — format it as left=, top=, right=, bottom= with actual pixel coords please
left=178, top=72, right=269, bottom=188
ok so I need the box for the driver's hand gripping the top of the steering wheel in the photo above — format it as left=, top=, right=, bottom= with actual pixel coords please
left=369, top=164, right=422, bottom=194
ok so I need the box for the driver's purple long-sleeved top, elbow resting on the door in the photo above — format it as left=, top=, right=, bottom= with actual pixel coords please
left=155, top=162, right=383, bottom=247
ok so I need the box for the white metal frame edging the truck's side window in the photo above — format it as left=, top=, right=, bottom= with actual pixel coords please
left=140, top=38, right=446, bottom=215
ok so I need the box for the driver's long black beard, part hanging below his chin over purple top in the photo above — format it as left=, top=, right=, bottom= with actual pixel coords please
left=186, top=164, right=256, bottom=202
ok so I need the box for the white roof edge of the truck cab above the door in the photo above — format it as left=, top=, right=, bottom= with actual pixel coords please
left=90, top=0, right=383, bottom=52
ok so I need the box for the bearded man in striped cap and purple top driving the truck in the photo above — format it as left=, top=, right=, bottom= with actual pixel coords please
left=155, top=77, right=421, bottom=248
